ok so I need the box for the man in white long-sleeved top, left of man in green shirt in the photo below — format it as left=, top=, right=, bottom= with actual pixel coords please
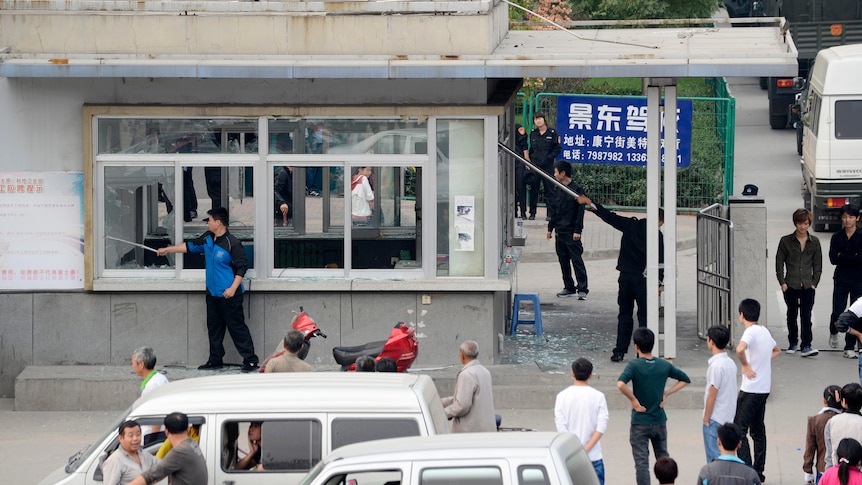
left=554, top=358, right=608, bottom=485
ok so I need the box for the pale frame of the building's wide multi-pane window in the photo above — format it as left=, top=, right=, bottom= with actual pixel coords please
left=84, top=106, right=499, bottom=291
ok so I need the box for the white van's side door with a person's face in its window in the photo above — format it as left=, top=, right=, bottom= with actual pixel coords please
left=213, top=413, right=326, bottom=485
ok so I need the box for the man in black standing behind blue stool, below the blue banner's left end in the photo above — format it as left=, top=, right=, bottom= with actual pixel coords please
left=545, top=160, right=590, bottom=300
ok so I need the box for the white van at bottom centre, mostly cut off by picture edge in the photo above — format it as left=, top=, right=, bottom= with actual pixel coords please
left=302, top=433, right=599, bottom=485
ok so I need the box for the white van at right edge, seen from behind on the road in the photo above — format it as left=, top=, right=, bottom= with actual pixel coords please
left=802, top=44, right=862, bottom=231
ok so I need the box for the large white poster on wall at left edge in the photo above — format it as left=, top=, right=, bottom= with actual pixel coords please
left=0, top=172, right=84, bottom=290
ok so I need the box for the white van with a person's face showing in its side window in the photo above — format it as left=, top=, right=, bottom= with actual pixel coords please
left=41, top=372, right=449, bottom=485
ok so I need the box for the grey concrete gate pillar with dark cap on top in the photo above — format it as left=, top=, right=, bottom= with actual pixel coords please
left=727, top=196, right=771, bottom=339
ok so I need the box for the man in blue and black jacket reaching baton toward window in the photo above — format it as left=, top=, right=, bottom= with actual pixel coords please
left=159, top=207, right=259, bottom=372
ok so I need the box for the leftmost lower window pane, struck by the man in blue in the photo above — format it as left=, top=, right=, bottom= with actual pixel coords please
left=104, top=166, right=177, bottom=269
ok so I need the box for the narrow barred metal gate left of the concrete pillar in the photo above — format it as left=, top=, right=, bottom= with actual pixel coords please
left=697, top=204, right=737, bottom=341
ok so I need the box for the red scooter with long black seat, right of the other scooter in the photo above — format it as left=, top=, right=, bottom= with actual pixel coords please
left=332, top=322, right=419, bottom=372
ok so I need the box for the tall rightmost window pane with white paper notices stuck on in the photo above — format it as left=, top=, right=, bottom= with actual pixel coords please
left=437, top=120, right=485, bottom=276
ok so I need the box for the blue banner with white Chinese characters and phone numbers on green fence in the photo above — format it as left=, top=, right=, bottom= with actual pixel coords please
left=557, top=96, right=692, bottom=167
